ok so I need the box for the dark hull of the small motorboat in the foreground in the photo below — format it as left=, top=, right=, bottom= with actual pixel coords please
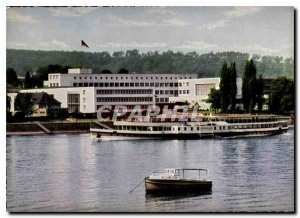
left=145, top=177, right=212, bottom=193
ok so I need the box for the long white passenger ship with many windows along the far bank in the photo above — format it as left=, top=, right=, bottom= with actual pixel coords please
left=90, top=116, right=289, bottom=140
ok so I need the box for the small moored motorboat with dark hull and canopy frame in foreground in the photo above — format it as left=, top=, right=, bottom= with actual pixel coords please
left=145, top=169, right=212, bottom=193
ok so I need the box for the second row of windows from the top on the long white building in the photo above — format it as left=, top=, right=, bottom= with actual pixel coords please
left=73, top=83, right=178, bottom=87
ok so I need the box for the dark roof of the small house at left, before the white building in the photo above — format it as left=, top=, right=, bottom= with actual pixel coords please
left=18, top=92, right=61, bottom=105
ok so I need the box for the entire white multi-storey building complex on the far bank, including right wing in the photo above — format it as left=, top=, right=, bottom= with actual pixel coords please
left=8, top=69, right=271, bottom=116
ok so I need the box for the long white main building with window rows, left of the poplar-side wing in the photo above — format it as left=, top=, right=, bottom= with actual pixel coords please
left=21, top=69, right=197, bottom=113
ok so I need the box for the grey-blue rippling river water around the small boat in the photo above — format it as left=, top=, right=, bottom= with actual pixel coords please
left=7, top=129, right=295, bottom=212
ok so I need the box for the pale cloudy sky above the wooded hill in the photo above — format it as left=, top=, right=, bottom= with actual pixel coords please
left=6, top=6, right=294, bottom=57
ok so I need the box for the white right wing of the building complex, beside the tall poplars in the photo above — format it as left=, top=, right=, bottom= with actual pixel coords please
left=170, top=77, right=242, bottom=110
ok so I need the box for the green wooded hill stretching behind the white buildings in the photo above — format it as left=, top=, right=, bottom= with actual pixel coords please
left=6, top=49, right=294, bottom=78
